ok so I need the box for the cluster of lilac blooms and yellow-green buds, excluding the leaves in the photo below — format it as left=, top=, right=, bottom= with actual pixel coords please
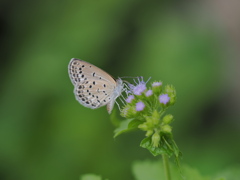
left=121, top=78, right=176, bottom=148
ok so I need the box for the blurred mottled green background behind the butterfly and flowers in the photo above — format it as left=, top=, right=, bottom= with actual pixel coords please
left=0, top=0, right=240, bottom=180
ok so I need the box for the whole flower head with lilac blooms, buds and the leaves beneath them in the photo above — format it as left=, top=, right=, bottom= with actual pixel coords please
left=114, top=77, right=181, bottom=161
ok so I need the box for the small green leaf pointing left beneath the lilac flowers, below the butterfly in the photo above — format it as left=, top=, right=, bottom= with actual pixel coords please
left=114, top=119, right=142, bottom=138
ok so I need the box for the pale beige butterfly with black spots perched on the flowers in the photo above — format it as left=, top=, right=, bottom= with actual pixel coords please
left=68, top=58, right=124, bottom=114
